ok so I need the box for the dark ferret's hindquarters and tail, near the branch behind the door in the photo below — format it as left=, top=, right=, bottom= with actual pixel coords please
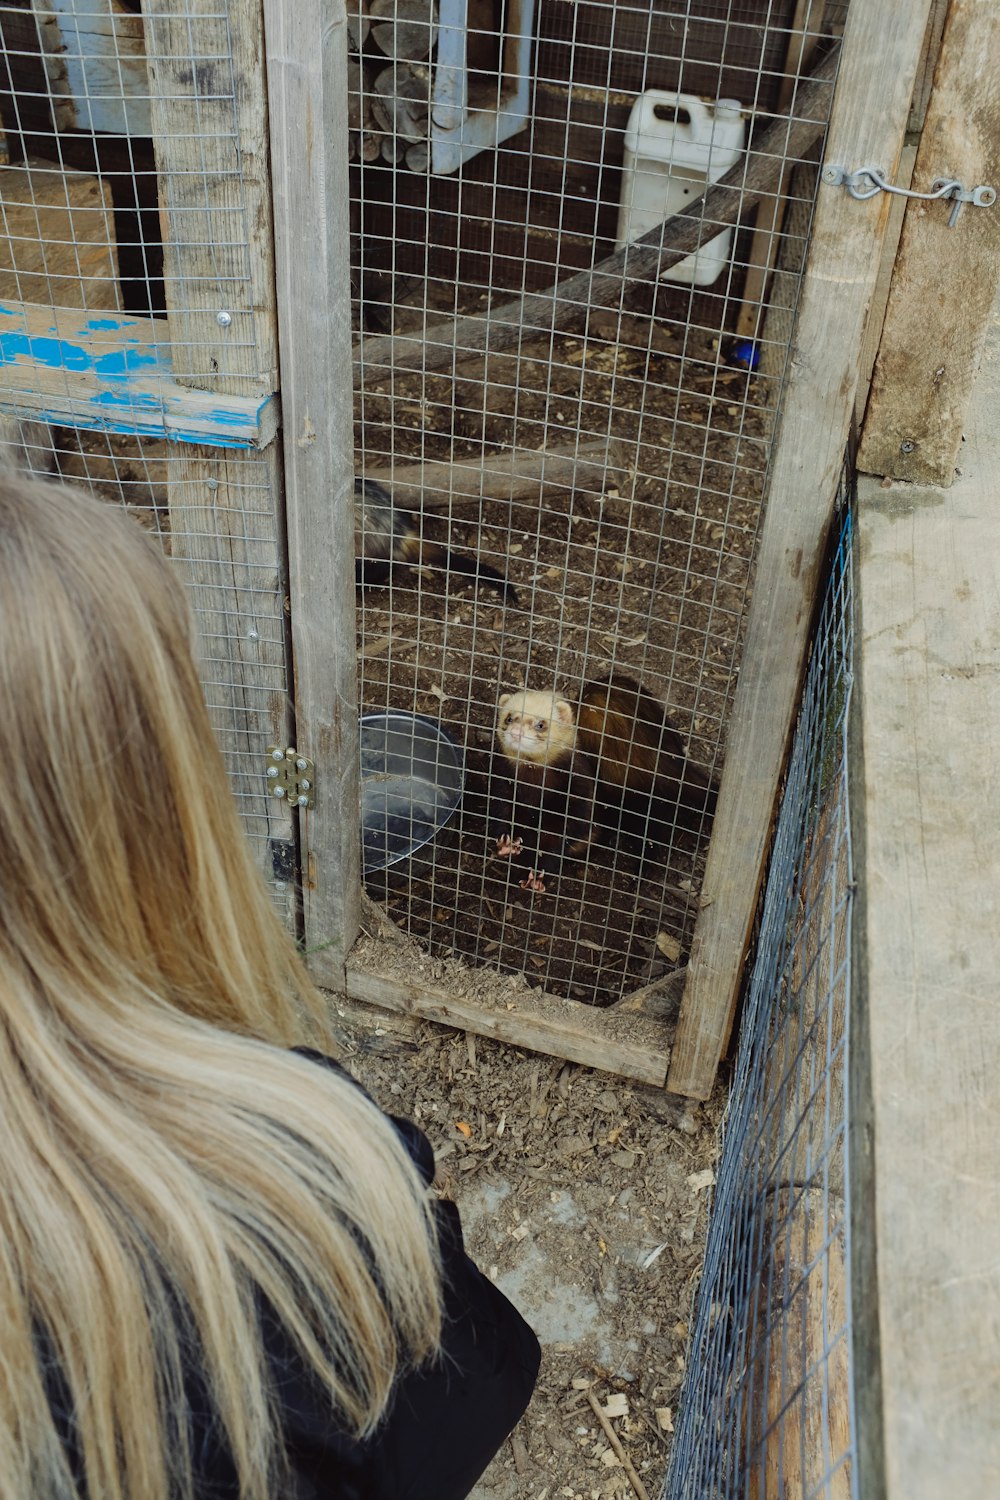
left=354, top=479, right=517, bottom=605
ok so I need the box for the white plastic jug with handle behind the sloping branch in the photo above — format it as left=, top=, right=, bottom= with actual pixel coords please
left=615, top=89, right=745, bottom=287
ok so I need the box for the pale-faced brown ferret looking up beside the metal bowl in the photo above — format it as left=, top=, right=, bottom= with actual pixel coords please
left=496, top=675, right=717, bottom=891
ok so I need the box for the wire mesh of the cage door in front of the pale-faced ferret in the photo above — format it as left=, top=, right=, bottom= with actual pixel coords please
left=351, top=0, right=846, bottom=1005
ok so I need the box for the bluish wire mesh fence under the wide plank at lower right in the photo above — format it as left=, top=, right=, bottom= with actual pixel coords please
left=663, top=498, right=858, bottom=1500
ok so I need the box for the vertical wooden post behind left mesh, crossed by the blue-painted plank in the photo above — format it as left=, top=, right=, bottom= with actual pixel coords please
left=142, top=0, right=294, bottom=923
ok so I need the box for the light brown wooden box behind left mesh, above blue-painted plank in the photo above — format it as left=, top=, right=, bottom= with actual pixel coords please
left=0, top=159, right=121, bottom=311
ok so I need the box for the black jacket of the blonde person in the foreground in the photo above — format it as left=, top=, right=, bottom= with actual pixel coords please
left=48, top=1049, right=540, bottom=1500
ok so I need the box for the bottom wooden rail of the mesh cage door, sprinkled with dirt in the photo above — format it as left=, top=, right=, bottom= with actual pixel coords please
left=346, top=966, right=669, bottom=1088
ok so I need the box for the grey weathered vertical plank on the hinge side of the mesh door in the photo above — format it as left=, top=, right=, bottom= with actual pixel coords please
left=264, top=0, right=361, bottom=990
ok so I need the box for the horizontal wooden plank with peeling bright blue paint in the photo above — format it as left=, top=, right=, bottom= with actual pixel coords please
left=0, top=302, right=277, bottom=449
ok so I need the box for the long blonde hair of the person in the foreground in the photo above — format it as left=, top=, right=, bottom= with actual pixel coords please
left=0, top=473, right=441, bottom=1500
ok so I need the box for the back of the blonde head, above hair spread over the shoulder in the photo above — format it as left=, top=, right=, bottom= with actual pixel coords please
left=0, top=474, right=316, bottom=1040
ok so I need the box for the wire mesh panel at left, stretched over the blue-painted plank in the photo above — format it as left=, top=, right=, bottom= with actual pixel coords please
left=0, top=0, right=291, bottom=899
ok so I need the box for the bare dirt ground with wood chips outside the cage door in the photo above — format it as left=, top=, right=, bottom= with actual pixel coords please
left=329, top=1007, right=723, bottom=1500
